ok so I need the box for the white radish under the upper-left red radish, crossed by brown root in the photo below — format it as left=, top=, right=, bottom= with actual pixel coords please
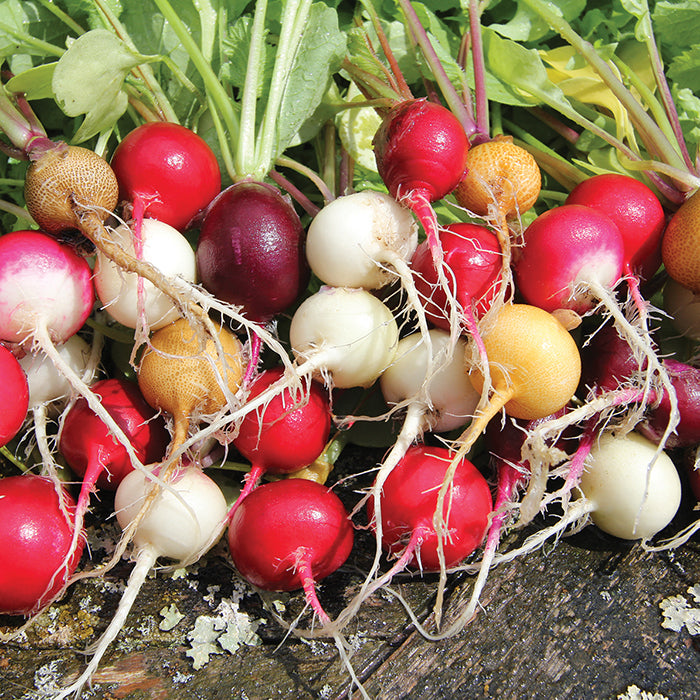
left=94, top=219, right=196, bottom=330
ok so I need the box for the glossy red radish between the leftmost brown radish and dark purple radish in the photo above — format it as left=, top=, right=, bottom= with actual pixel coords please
left=110, top=122, right=221, bottom=231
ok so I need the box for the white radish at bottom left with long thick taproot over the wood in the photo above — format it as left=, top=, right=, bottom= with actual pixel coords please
left=55, top=466, right=226, bottom=700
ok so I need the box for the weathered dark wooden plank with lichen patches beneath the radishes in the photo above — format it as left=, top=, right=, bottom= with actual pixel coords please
left=0, top=450, right=700, bottom=700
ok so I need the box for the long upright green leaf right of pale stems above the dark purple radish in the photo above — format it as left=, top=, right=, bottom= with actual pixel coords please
left=275, top=3, right=346, bottom=157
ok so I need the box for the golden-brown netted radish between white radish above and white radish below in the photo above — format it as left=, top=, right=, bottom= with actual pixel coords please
left=138, top=318, right=243, bottom=459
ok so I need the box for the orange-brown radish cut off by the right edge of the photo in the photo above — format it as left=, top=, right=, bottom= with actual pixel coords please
left=661, top=190, right=700, bottom=294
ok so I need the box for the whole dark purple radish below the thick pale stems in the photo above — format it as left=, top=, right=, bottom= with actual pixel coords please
left=197, top=181, right=309, bottom=322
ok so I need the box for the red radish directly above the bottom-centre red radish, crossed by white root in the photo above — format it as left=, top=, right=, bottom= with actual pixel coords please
left=233, top=367, right=331, bottom=474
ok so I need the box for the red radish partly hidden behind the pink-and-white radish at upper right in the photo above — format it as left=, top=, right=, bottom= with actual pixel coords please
left=566, top=173, right=666, bottom=279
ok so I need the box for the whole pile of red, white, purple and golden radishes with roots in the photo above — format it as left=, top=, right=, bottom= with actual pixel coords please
left=0, top=0, right=700, bottom=697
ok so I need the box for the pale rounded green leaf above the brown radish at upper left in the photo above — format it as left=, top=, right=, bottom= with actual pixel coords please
left=52, top=29, right=153, bottom=143
